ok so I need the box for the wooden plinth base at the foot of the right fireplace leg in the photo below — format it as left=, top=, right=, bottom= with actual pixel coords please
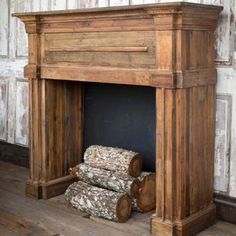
left=151, top=203, right=216, bottom=236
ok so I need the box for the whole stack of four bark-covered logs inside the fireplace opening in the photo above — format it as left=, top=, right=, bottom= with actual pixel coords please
left=65, top=145, right=156, bottom=222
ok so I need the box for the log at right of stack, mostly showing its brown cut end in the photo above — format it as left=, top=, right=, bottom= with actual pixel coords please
left=132, top=171, right=156, bottom=212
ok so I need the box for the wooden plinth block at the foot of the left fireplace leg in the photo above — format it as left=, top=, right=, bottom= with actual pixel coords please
left=26, top=175, right=77, bottom=199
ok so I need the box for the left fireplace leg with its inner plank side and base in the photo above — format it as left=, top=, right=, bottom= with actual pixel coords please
left=26, top=79, right=82, bottom=199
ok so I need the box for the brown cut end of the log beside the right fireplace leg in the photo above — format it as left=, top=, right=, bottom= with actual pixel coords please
left=137, top=174, right=156, bottom=212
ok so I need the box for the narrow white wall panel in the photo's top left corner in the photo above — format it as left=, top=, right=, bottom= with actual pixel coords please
left=0, top=0, right=9, bottom=56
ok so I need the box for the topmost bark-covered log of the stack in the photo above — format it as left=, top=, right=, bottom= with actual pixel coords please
left=84, top=145, right=142, bottom=177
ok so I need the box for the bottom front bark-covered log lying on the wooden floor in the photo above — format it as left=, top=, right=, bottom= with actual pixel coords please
left=65, top=181, right=131, bottom=222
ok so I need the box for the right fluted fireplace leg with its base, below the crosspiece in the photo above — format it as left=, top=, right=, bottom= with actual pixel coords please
left=152, top=85, right=216, bottom=236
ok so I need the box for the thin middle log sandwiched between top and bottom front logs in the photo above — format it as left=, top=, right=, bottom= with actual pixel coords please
left=71, top=163, right=140, bottom=196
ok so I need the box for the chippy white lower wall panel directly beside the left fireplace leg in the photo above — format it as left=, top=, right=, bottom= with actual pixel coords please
left=15, top=81, right=28, bottom=145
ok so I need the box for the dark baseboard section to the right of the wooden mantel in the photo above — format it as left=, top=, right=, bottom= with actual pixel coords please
left=214, top=193, right=236, bottom=224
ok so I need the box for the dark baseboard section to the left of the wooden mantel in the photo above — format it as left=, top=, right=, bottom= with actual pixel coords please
left=0, top=141, right=29, bottom=168
